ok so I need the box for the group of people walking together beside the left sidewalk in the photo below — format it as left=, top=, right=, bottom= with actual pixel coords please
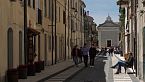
left=71, top=44, right=97, bottom=67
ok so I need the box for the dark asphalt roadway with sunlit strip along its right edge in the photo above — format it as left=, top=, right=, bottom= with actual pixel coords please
left=67, top=56, right=113, bottom=82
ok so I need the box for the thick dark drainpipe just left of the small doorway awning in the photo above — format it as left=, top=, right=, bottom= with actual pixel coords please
left=24, top=0, right=28, bottom=64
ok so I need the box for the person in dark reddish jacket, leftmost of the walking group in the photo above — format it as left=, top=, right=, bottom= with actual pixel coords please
left=71, top=45, right=80, bottom=66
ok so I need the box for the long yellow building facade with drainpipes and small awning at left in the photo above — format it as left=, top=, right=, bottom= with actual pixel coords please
left=0, top=0, right=85, bottom=82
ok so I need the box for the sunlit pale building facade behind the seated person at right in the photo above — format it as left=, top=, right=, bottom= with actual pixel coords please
left=117, top=0, right=145, bottom=82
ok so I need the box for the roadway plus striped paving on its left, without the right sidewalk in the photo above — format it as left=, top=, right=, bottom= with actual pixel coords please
left=45, top=55, right=113, bottom=82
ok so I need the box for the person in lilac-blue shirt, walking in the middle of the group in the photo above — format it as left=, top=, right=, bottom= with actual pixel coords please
left=81, top=44, right=89, bottom=67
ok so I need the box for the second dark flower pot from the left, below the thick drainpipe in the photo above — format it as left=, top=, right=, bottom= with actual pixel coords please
left=18, top=65, right=27, bottom=79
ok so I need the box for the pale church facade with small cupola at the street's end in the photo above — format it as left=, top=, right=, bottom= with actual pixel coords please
left=97, top=16, right=119, bottom=48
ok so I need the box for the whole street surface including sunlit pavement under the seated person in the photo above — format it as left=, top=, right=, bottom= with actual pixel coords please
left=42, top=53, right=139, bottom=82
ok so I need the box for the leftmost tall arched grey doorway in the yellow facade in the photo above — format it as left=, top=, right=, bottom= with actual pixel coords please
left=7, top=28, right=13, bottom=69
